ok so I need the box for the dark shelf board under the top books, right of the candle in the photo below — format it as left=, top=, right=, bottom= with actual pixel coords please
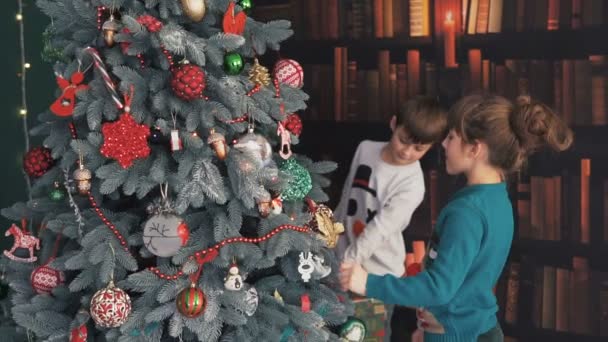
left=461, top=27, right=608, bottom=60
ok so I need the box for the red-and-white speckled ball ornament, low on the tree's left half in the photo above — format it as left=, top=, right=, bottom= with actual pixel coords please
left=91, top=281, right=131, bottom=328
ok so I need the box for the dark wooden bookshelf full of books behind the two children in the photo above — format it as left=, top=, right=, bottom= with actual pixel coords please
left=253, top=0, right=608, bottom=342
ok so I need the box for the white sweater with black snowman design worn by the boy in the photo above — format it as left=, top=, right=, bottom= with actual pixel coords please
left=335, top=140, right=424, bottom=277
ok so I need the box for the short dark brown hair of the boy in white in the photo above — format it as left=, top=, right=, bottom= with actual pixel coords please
left=397, top=96, right=447, bottom=144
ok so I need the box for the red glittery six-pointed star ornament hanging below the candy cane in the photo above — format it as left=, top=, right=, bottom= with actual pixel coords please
left=101, top=111, right=150, bottom=169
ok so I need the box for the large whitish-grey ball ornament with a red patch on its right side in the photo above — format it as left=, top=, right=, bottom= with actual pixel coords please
left=143, top=214, right=190, bottom=257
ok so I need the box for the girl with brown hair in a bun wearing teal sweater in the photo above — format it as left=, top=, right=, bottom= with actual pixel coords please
left=340, top=95, right=572, bottom=342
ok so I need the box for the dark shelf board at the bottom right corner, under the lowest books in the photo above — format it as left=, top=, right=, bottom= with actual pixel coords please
left=501, top=322, right=608, bottom=342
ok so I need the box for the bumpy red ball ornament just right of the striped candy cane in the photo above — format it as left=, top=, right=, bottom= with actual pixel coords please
left=171, top=64, right=206, bottom=101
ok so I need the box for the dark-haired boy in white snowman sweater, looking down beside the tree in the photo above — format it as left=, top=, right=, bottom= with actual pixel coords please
left=335, top=96, right=447, bottom=341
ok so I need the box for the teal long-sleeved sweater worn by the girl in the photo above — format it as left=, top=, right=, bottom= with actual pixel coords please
left=366, top=183, right=513, bottom=342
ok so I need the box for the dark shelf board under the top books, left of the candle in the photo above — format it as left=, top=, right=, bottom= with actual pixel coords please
left=281, top=36, right=434, bottom=65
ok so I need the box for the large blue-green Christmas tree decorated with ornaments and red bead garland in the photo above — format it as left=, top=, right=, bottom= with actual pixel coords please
left=2, top=0, right=352, bottom=341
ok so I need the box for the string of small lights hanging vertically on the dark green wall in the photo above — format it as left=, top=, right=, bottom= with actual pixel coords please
left=15, top=0, right=32, bottom=201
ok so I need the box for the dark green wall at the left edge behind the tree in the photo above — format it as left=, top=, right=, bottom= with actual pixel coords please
left=0, top=0, right=56, bottom=246
